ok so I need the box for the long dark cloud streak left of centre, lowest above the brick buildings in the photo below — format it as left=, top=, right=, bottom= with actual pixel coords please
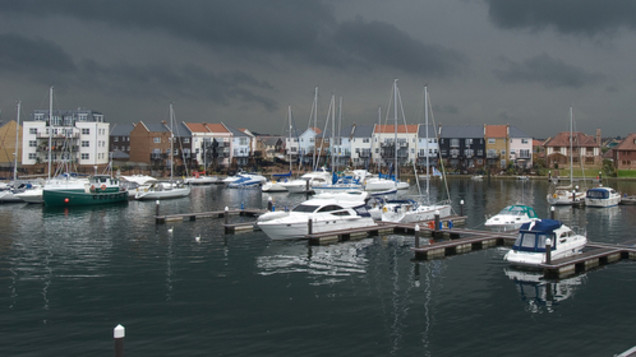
left=78, top=60, right=278, bottom=111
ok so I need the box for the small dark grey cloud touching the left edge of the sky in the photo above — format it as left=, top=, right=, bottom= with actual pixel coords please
left=0, top=33, right=75, bottom=76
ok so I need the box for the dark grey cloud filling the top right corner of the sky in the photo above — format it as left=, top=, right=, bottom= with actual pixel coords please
left=485, top=0, right=636, bottom=35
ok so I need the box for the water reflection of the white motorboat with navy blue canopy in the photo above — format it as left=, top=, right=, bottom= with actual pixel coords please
left=504, top=267, right=586, bottom=314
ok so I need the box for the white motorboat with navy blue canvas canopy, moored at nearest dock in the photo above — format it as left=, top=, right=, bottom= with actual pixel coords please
left=504, top=219, right=587, bottom=268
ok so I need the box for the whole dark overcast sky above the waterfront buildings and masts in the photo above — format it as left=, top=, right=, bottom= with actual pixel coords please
left=0, top=0, right=636, bottom=138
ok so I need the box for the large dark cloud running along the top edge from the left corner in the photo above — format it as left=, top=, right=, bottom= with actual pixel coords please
left=0, top=0, right=335, bottom=52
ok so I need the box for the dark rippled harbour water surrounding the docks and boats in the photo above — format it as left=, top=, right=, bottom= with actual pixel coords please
left=0, top=179, right=636, bottom=356
